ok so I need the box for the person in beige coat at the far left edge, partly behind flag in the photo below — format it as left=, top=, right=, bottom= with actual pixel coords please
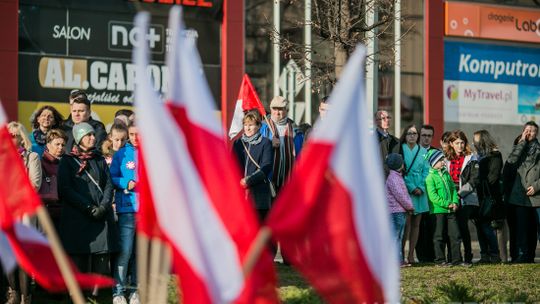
left=6, top=121, right=42, bottom=304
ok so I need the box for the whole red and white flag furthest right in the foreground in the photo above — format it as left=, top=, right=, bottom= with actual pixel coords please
left=267, top=46, right=400, bottom=303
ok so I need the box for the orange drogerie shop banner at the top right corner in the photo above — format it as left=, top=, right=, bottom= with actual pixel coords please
left=445, top=2, right=540, bottom=43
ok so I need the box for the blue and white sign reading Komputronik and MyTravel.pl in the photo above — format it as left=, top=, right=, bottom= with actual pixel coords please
left=444, top=41, right=540, bottom=125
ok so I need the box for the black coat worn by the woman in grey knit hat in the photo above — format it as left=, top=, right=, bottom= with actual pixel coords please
left=58, top=155, right=119, bottom=254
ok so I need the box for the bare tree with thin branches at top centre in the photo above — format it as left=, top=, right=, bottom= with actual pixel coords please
left=267, top=0, right=411, bottom=91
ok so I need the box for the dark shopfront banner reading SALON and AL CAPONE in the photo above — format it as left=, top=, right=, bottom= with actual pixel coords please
left=19, top=0, right=221, bottom=128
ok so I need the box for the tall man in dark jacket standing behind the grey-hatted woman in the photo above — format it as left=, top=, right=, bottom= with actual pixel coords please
left=62, top=90, right=107, bottom=153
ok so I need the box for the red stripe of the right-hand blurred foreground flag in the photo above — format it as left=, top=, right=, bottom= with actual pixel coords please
left=268, top=142, right=385, bottom=303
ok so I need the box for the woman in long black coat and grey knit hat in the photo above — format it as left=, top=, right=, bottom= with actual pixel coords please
left=58, top=123, right=119, bottom=286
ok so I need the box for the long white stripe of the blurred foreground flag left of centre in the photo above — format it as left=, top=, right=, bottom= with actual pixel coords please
left=134, top=8, right=244, bottom=302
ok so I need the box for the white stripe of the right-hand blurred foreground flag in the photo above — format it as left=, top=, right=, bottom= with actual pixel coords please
left=311, top=46, right=399, bottom=303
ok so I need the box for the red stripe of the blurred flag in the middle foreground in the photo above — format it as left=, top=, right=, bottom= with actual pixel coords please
left=167, top=103, right=277, bottom=303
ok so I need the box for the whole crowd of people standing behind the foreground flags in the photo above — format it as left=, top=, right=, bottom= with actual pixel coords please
left=4, top=90, right=540, bottom=304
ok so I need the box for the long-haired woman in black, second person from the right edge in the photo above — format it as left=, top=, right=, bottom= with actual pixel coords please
left=474, top=130, right=503, bottom=263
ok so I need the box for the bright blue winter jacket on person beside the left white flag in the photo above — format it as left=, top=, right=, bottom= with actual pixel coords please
left=111, top=143, right=139, bottom=213
